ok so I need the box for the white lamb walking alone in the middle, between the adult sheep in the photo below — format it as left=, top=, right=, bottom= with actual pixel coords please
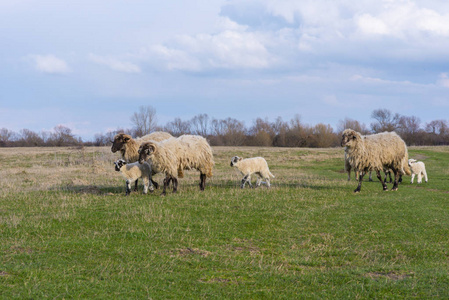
left=231, top=156, right=274, bottom=189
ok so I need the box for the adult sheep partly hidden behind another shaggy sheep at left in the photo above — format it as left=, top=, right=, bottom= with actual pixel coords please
left=111, top=131, right=172, bottom=190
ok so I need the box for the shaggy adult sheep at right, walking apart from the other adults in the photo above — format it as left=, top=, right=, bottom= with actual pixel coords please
left=341, top=129, right=411, bottom=193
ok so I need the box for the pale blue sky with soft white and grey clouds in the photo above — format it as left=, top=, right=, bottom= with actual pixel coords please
left=0, top=0, right=449, bottom=141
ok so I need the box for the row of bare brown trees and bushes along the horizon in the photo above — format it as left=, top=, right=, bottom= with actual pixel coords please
left=0, top=106, right=449, bottom=148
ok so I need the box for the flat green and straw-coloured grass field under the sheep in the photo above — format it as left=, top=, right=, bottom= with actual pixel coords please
left=0, top=147, right=449, bottom=299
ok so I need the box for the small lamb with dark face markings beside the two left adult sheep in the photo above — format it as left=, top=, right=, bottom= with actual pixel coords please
left=114, top=158, right=154, bottom=196
